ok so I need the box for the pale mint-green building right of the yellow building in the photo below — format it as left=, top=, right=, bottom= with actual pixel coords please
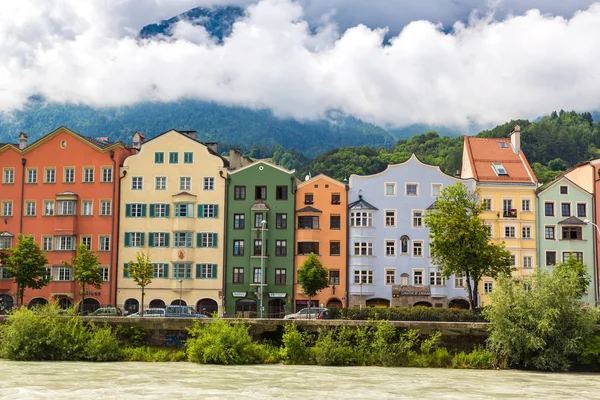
left=537, top=174, right=596, bottom=304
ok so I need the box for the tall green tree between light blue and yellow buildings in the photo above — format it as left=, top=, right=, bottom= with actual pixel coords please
left=424, top=183, right=511, bottom=310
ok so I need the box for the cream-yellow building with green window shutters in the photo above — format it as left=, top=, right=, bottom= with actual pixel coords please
left=117, top=130, right=227, bottom=314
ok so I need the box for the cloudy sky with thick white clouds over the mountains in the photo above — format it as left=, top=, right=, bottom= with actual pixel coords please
left=0, top=0, right=600, bottom=127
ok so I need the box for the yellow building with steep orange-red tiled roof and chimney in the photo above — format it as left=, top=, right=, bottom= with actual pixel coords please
left=461, top=125, right=538, bottom=306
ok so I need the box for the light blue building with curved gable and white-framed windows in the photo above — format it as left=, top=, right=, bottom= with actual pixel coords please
left=348, top=154, right=475, bottom=308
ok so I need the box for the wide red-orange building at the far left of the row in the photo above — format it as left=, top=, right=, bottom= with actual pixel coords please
left=0, top=127, right=131, bottom=308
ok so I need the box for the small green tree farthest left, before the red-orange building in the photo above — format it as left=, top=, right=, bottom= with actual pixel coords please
left=4, top=235, right=50, bottom=306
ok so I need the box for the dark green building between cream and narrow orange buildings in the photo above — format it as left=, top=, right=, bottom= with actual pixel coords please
left=224, top=161, right=296, bottom=318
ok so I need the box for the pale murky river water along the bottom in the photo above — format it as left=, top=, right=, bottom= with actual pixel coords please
left=0, top=361, right=600, bottom=400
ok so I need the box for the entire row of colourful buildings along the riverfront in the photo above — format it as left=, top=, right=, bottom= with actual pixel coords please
left=0, top=126, right=600, bottom=316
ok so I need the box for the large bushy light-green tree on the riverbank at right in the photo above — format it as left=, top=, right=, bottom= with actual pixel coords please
left=484, top=269, right=597, bottom=371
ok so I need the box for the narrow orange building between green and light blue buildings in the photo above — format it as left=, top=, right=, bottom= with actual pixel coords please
left=294, top=174, right=348, bottom=311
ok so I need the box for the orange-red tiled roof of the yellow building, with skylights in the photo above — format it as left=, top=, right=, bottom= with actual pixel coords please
left=463, top=136, right=537, bottom=184
